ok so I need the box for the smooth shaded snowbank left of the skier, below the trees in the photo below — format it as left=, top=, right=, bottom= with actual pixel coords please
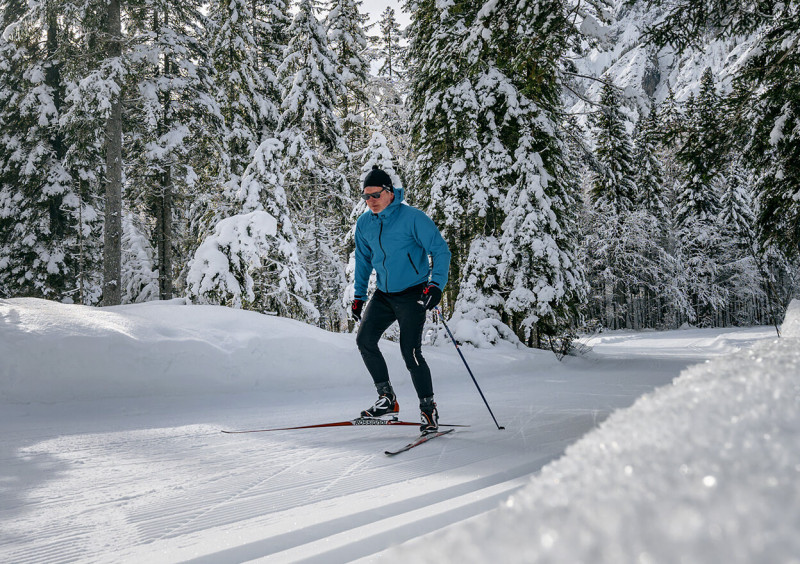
left=0, top=298, right=365, bottom=403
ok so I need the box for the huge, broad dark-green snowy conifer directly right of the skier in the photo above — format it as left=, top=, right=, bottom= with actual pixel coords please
left=409, top=1, right=583, bottom=345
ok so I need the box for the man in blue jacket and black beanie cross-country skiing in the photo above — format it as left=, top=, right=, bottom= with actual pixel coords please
left=351, top=166, right=450, bottom=433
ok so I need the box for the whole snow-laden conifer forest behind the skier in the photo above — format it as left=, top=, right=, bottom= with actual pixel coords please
left=0, top=0, right=800, bottom=351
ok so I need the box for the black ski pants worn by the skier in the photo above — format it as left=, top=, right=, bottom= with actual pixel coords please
left=356, top=284, right=433, bottom=399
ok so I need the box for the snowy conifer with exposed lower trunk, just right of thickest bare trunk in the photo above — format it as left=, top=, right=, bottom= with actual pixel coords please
left=123, top=0, right=224, bottom=299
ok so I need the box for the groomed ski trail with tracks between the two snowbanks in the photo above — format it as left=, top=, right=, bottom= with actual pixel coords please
left=0, top=318, right=770, bottom=564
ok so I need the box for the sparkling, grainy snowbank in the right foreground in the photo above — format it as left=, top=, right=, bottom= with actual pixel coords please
left=406, top=301, right=800, bottom=564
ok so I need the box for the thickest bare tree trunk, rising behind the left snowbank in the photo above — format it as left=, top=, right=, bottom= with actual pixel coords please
left=103, top=0, right=122, bottom=306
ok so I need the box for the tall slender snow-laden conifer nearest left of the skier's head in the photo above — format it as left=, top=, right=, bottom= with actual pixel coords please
left=278, top=0, right=353, bottom=328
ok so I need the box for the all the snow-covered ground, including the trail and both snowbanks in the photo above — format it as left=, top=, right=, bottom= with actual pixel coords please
left=0, top=299, right=800, bottom=563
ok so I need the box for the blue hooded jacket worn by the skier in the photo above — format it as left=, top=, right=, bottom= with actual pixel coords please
left=355, top=188, right=450, bottom=300
